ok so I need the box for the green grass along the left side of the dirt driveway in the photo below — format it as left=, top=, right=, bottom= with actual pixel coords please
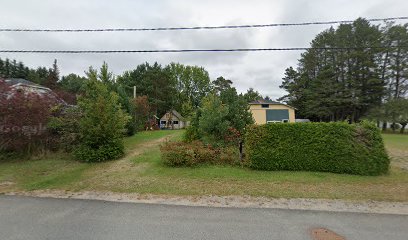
left=0, top=131, right=181, bottom=192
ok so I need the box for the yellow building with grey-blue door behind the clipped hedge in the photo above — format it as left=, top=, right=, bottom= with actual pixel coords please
left=249, top=100, right=296, bottom=124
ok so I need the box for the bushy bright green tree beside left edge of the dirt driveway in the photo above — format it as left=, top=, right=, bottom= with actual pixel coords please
left=74, top=79, right=129, bottom=162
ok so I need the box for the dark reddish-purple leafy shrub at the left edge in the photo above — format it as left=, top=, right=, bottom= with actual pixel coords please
left=0, top=80, right=58, bottom=154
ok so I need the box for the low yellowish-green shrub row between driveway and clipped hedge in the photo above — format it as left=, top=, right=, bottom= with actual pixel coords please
left=160, top=141, right=239, bottom=167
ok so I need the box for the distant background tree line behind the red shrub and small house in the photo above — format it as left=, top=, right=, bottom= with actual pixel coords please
left=0, top=58, right=261, bottom=116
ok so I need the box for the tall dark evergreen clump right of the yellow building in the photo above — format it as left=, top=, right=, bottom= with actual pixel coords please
left=280, top=18, right=408, bottom=131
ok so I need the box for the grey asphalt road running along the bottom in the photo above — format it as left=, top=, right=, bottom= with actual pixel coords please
left=0, top=195, right=408, bottom=240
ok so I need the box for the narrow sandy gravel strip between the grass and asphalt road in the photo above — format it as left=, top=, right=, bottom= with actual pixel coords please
left=4, top=190, right=408, bottom=215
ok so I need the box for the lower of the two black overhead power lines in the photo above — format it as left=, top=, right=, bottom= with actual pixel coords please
left=0, top=46, right=408, bottom=54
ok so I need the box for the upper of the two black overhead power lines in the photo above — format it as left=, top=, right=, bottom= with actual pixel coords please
left=0, top=17, right=408, bottom=32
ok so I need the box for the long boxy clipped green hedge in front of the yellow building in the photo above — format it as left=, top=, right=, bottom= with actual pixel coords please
left=245, top=122, right=390, bottom=175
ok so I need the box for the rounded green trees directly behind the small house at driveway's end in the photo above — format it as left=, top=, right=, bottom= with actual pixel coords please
left=118, top=63, right=211, bottom=118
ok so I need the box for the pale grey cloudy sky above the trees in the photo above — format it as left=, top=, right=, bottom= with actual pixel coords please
left=0, top=0, right=408, bottom=99
